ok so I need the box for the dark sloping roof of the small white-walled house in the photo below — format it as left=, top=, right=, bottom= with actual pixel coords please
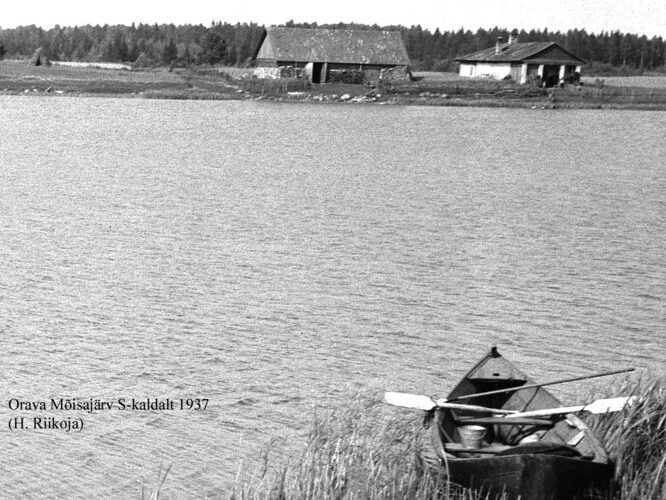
left=456, top=42, right=585, bottom=64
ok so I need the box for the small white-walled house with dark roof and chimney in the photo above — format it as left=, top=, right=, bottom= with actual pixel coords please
left=456, top=37, right=585, bottom=87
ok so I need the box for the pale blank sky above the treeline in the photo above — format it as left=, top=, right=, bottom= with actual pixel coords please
left=0, top=0, right=666, bottom=38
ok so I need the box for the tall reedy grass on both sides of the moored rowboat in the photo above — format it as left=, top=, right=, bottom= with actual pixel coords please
left=232, top=377, right=666, bottom=500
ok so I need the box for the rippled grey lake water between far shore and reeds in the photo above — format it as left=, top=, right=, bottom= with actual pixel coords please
left=0, top=96, right=666, bottom=498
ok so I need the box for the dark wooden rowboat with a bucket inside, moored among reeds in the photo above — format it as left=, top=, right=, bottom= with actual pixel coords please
left=432, top=348, right=613, bottom=500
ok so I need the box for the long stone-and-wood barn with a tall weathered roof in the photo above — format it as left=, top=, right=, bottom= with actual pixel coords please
left=255, top=27, right=410, bottom=83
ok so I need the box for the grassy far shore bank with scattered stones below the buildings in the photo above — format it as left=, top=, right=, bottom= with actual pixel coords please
left=0, top=61, right=666, bottom=111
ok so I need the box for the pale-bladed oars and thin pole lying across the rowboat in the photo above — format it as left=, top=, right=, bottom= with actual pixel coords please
left=384, top=368, right=637, bottom=419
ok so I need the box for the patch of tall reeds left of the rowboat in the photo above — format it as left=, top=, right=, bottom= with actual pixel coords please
left=232, top=396, right=486, bottom=500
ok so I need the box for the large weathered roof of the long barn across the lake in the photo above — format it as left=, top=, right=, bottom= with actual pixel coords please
left=255, top=28, right=410, bottom=66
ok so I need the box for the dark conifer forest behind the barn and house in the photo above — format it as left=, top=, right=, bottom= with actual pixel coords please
left=0, top=21, right=666, bottom=74
